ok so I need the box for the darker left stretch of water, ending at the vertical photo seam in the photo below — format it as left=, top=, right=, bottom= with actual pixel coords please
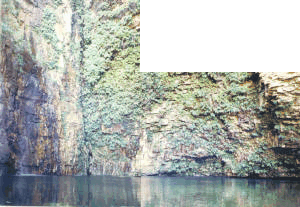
left=0, top=176, right=140, bottom=206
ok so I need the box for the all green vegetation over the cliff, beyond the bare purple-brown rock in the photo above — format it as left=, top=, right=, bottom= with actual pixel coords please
left=1, top=0, right=300, bottom=176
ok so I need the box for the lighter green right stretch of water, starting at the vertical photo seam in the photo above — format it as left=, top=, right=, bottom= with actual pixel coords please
left=141, top=177, right=300, bottom=207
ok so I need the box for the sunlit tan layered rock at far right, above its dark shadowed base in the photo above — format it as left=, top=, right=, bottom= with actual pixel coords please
left=259, top=72, right=300, bottom=148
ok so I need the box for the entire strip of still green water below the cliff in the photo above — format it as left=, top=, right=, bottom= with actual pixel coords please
left=0, top=176, right=300, bottom=207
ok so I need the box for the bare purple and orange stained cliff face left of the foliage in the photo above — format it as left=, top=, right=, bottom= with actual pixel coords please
left=0, top=0, right=82, bottom=174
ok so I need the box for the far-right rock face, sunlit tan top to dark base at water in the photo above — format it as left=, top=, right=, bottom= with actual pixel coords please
left=259, top=72, right=300, bottom=176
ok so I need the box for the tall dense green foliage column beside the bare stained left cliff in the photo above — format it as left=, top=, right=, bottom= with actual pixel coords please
left=77, top=1, right=142, bottom=175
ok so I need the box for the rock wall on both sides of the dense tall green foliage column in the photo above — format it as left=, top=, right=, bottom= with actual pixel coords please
left=0, top=0, right=300, bottom=176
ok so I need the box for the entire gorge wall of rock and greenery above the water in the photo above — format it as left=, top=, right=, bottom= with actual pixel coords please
left=0, top=0, right=300, bottom=180
